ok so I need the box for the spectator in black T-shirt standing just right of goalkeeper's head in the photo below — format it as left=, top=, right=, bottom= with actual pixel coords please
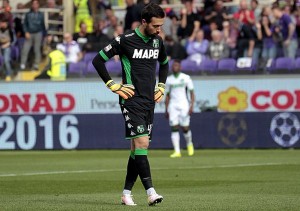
left=178, top=0, right=201, bottom=45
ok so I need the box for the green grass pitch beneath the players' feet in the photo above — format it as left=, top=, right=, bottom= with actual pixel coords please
left=0, top=149, right=300, bottom=211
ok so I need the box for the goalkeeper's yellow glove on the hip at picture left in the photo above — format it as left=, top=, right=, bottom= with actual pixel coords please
left=105, top=80, right=134, bottom=100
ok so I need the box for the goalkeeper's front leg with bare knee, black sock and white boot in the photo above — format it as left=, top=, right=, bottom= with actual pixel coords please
left=133, top=136, right=163, bottom=206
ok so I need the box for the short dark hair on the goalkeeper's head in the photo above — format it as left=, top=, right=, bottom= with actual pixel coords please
left=141, top=2, right=166, bottom=23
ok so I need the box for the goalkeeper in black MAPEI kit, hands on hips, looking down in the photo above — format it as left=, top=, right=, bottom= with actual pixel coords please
left=93, top=3, right=168, bottom=206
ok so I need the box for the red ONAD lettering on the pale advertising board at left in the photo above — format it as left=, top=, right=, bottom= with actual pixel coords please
left=0, top=93, right=75, bottom=114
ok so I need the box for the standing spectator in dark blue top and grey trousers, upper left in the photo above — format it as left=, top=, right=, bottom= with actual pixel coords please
left=20, top=0, right=46, bottom=70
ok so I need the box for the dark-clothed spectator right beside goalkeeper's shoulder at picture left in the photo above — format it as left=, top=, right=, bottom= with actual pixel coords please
left=86, top=20, right=110, bottom=52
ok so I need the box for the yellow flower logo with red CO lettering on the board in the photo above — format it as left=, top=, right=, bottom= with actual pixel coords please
left=218, top=87, right=300, bottom=112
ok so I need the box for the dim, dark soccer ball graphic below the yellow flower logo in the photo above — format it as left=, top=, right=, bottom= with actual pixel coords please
left=218, top=114, right=247, bottom=146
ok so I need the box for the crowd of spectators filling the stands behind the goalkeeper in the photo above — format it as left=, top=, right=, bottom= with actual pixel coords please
left=0, top=0, right=300, bottom=81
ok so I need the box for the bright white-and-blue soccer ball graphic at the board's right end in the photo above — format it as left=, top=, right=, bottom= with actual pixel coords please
left=270, top=113, right=300, bottom=147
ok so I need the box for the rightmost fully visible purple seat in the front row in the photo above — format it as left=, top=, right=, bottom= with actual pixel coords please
left=269, top=57, right=295, bottom=73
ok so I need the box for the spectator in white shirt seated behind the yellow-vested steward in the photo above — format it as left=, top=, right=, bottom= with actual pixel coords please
left=57, top=32, right=83, bottom=64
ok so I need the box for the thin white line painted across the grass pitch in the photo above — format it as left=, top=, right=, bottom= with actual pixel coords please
left=0, top=163, right=295, bottom=177
